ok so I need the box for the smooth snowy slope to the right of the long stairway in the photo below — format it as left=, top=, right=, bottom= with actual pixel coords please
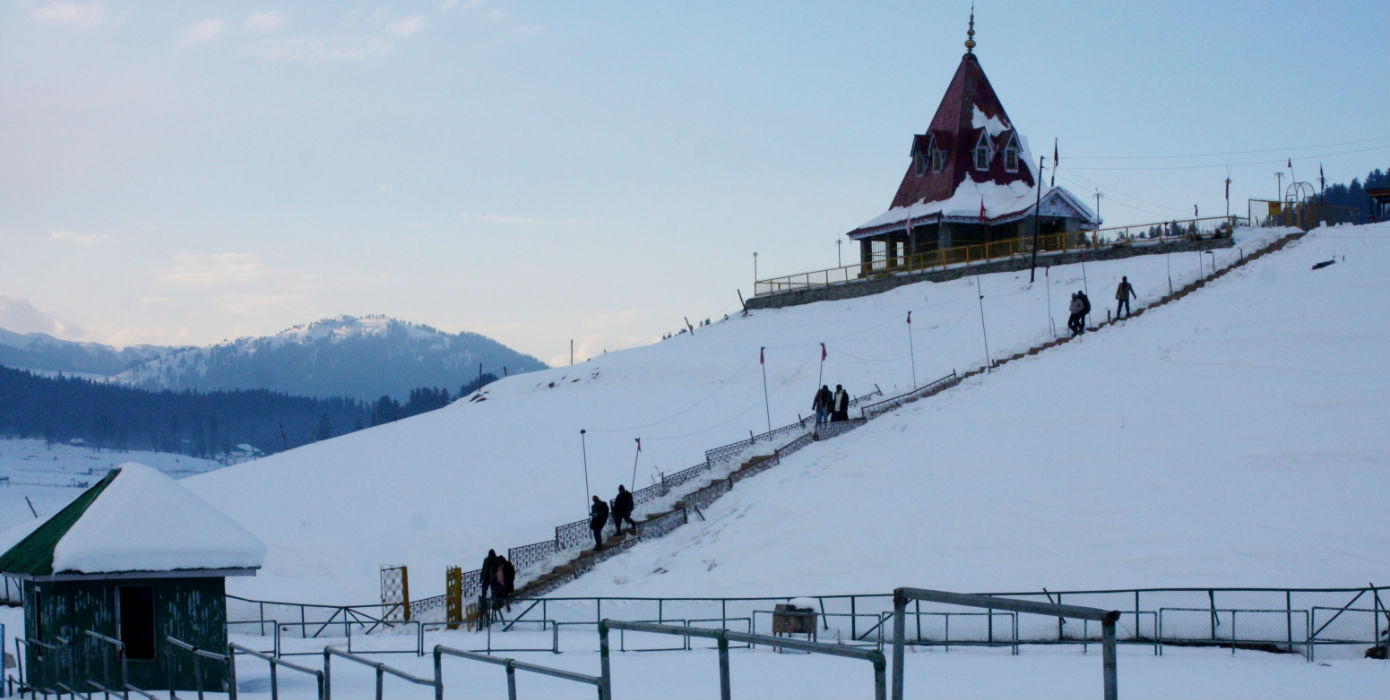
left=556, top=226, right=1390, bottom=596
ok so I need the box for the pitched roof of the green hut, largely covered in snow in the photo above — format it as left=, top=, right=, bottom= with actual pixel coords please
left=0, top=463, right=265, bottom=578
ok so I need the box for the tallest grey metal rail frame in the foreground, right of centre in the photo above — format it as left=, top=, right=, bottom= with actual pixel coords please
left=892, top=588, right=1120, bottom=700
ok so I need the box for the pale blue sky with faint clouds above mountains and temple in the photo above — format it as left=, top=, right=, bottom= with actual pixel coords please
left=0, top=0, right=1390, bottom=364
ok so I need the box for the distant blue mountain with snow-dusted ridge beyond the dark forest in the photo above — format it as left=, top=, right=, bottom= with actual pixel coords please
left=113, top=315, right=545, bottom=400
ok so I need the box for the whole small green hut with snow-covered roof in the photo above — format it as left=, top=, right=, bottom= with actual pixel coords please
left=0, top=463, right=265, bottom=693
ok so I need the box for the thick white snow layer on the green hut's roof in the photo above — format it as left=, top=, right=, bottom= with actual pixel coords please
left=53, top=463, right=265, bottom=574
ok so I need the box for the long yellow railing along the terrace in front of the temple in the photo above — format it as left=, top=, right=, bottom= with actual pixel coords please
left=753, top=217, right=1243, bottom=296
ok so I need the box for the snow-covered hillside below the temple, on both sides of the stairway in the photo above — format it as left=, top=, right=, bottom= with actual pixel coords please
left=186, top=226, right=1390, bottom=603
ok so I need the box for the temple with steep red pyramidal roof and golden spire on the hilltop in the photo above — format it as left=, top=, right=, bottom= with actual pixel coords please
left=848, top=11, right=1099, bottom=269
